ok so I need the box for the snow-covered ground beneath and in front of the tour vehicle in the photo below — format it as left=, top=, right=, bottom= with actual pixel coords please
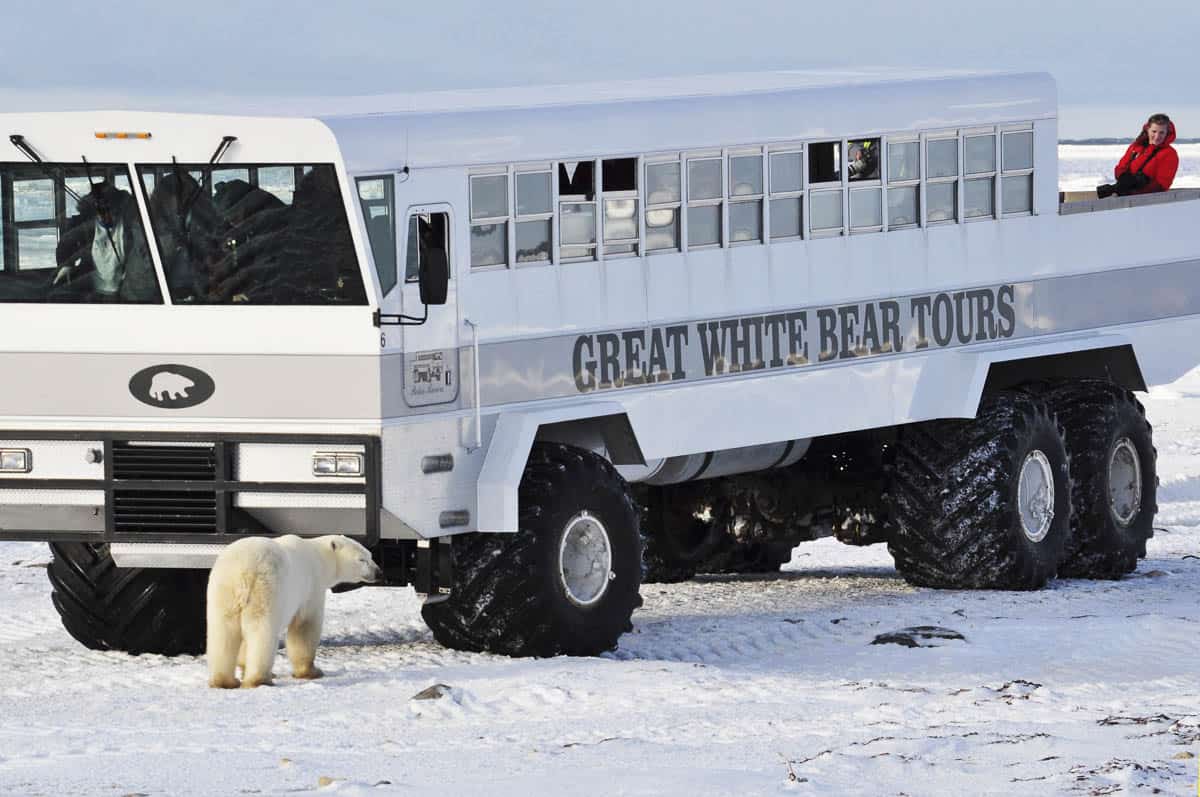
left=0, top=371, right=1200, bottom=796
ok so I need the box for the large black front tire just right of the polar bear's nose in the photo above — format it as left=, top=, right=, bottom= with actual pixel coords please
left=421, top=443, right=642, bottom=657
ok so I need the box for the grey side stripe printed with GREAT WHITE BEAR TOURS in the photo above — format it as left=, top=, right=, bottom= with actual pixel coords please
left=463, top=259, right=1200, bottom=414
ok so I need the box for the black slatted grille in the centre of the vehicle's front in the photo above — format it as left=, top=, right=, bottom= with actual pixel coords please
left=112, top=441, right=217, bottom=534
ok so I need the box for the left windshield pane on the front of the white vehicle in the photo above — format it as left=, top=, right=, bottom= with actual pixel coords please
left=0, top=163, right=162, bottom=304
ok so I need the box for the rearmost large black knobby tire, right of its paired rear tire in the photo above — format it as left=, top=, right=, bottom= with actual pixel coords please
left=1044, top=380, right=1158, bottom=579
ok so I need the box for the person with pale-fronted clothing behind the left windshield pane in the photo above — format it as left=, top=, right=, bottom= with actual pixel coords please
left=52, top=181, right=160, bottom=302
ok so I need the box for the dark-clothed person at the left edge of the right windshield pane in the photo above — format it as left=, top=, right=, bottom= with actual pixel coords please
left=150, top=172, right=223, bottom=302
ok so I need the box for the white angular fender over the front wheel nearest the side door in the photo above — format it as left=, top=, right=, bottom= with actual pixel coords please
left=475, top=401, right=625, bottom=533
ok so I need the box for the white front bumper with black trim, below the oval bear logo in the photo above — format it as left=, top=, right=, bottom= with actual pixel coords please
left=0, top=431, right=382, bottom=546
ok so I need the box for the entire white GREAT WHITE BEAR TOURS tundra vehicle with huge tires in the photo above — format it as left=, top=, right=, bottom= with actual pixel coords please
left=0, top=74, right=1200, bottom=655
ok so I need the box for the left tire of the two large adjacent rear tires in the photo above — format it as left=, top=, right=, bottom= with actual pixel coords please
left=888, top=391, right=1070, bottom=589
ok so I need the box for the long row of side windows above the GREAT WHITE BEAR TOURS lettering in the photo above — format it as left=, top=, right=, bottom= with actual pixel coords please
left=468, top=125, right=1033, bottom=269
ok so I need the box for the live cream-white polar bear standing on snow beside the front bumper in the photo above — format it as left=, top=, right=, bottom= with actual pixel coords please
left=208, top=534, right=380, bottom=689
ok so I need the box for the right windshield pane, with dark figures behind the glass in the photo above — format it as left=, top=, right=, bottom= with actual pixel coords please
left=138, top=163, right=366, bottom=305
